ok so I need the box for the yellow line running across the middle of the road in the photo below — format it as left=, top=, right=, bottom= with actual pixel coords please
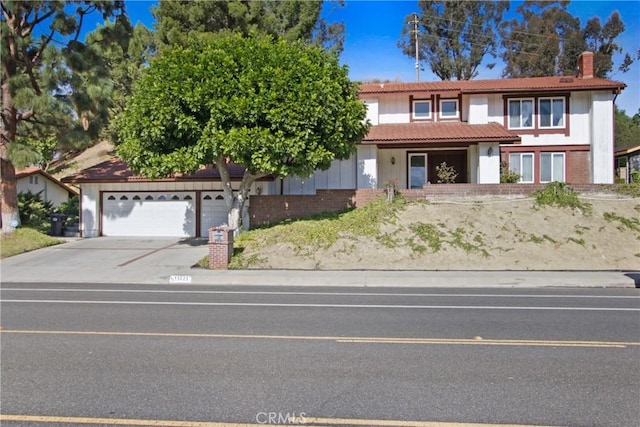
left=0, top=329, right=640, bottom=348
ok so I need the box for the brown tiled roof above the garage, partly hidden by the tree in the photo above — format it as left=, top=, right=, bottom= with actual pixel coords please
left=62, top=158, right=264, bottom=184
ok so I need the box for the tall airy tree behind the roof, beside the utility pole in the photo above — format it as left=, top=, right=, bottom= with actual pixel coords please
left=398, top=0, right=509, bottom=80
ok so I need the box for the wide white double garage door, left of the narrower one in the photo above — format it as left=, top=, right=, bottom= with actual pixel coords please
left=102, top=192, right=196, bottom=237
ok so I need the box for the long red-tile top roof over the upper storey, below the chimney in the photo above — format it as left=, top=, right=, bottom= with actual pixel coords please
left=360, top=76, right=627, bottom=96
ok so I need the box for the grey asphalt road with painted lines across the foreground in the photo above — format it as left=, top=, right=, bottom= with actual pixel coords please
left=0, top=283, right=640, bottom=426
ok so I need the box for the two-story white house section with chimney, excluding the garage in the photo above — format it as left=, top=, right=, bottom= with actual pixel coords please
left=271, top=52, right=625, bottom=194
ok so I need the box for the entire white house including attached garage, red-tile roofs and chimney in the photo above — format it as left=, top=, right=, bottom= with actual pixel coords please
left=63, top=53, right=625, bottom=237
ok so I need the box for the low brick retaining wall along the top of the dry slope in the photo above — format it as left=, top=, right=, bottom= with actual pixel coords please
left=249, top=185, right=611, bottom=228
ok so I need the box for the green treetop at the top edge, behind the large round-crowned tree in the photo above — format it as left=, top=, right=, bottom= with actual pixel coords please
left=153, top=0, right=344, bottom=52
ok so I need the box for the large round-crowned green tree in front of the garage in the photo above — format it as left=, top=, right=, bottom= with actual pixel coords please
left=118, top=35, right=368, bottom=228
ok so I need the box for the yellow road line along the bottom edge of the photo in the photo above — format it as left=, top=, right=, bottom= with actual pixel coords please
left=0, top=414, right=560, bottom=427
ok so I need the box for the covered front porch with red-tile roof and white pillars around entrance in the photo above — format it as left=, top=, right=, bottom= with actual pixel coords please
left=358, top=122, right=520, bottom=189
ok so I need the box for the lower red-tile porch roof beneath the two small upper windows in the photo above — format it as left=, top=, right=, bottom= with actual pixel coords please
left=362, top=122, right=520, bottom=145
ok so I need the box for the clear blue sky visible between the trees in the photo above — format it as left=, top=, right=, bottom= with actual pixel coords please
left=126, top=0, right=640, bottom=116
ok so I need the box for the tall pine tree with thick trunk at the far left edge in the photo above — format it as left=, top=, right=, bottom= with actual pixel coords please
left=0, top=0, right=124, bottom=232
